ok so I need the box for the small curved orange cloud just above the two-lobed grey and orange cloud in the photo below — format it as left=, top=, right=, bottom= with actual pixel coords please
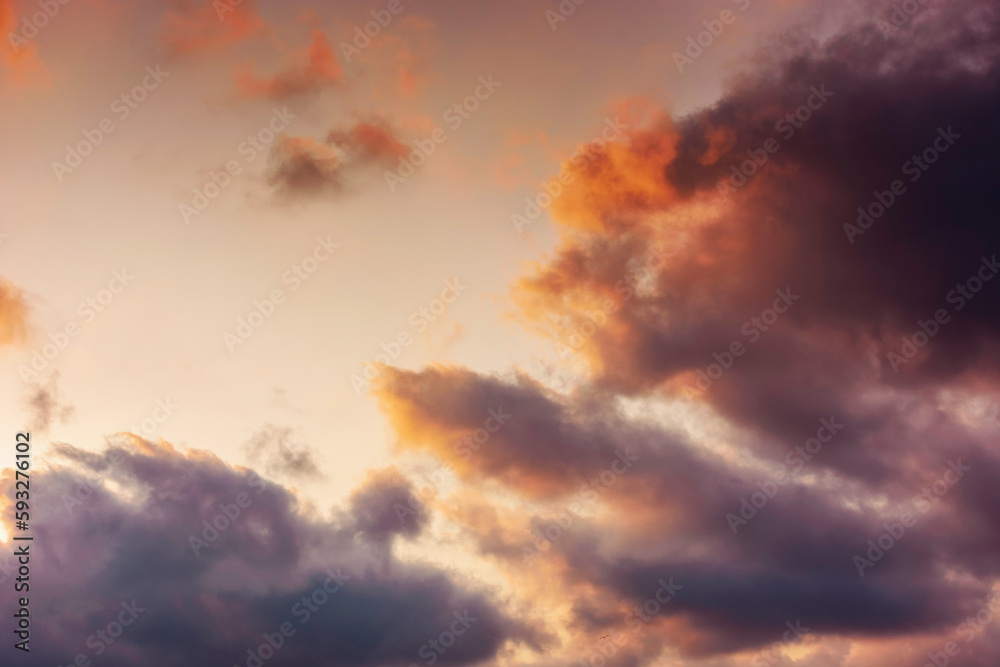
left=236, top=30, right=343, bottom=100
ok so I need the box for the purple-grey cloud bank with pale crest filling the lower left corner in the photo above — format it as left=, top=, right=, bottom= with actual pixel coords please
left=0, top=435, right=534, bottom=667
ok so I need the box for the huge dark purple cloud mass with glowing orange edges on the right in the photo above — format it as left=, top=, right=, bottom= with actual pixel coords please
left=377, top=2, right=1000, bottom=667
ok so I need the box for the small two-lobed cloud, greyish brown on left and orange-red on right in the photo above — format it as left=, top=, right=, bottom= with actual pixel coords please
left=268, top=118, right=409, bottom=198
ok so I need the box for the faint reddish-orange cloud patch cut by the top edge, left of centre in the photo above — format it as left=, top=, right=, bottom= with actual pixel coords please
left=159, top=0, right=267, bottom=55
